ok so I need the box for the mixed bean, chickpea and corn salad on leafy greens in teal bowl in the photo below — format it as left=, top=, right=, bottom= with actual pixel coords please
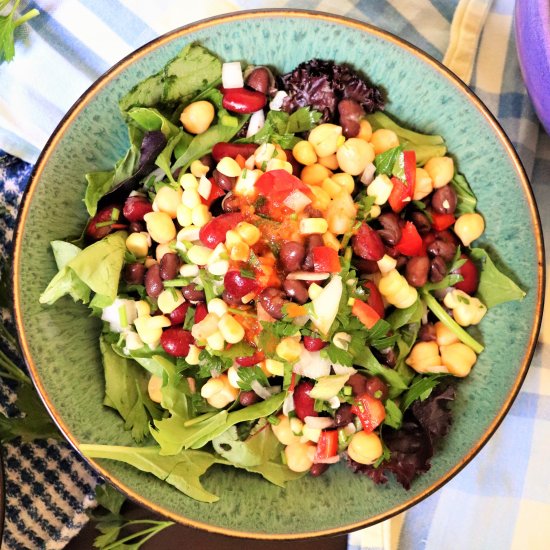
left=40, top=44, right=524, bottom=502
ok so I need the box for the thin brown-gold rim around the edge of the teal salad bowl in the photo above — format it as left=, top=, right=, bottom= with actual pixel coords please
left=12, top=8, right=546, bottom=540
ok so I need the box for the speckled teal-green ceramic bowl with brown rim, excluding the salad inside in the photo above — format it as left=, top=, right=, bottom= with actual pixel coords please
left=14, top=10, right=544, bottom=538
